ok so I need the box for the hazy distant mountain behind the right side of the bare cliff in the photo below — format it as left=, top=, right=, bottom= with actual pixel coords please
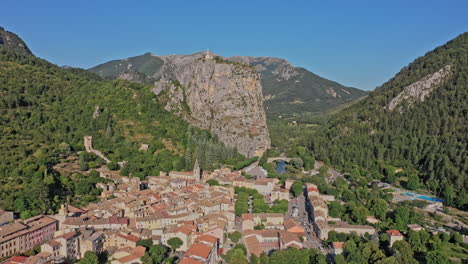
left=228, top=56, right=366, bottom=116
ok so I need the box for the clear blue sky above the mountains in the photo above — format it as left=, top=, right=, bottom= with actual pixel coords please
left=0, top=0, right=468, bottom=90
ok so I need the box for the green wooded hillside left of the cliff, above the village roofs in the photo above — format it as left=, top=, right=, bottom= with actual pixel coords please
left=0, top=48, right=244, bottom=215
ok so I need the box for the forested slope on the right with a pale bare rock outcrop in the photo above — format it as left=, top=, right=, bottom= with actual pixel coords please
left=309, top=33, right=468, bottom=206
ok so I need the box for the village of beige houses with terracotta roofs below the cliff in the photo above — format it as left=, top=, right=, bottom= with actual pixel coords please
left=0, top=137, right=464, bottom=264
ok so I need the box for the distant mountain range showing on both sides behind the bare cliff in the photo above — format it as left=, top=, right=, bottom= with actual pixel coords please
left=89, top=53, right=366, bottom=117
